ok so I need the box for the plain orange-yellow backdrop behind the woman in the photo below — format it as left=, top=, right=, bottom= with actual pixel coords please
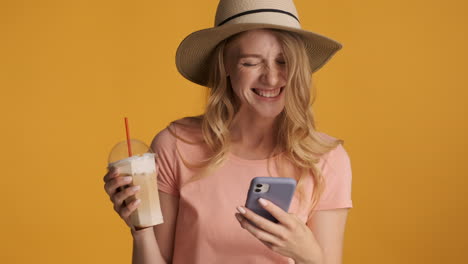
left=0, top=0, right=468, bottom=264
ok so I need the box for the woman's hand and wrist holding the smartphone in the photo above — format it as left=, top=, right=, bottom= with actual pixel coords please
left=236, top=199, right=322, bottom=264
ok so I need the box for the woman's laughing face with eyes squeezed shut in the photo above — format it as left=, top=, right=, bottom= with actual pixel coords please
left=224, top=29, right=287, bottom=118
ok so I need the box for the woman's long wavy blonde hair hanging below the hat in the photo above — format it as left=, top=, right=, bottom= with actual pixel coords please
left=170, top=29, right=342, bottom=217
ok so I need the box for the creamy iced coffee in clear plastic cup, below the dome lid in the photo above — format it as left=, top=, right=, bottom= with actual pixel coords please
left=109, top=153, right=163, bottom=228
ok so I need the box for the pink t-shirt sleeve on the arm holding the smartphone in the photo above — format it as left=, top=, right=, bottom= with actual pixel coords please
left=315, top=144, right=353, bottom=210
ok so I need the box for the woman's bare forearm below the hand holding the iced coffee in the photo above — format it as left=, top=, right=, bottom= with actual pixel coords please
left=132, top=228, right=167, bottom=264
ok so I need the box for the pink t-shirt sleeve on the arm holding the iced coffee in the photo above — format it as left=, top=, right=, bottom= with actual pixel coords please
left=151, top=127, right=179, bottom=195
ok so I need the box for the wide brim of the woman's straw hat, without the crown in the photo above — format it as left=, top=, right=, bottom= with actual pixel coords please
left=176, top=23, right=343, bottom=86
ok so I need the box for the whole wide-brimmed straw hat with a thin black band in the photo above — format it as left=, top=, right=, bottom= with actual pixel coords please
left=176, top=0, right=342, bottom=86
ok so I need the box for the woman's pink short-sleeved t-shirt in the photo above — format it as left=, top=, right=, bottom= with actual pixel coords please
left=154, top=118, right=352, bottom=264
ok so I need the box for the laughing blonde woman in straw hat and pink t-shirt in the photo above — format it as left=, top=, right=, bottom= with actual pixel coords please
left=104, top=0, right=352, bottom=263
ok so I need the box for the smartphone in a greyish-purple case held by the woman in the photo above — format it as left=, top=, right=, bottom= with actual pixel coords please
left=245, top=177, right=296, bottom=223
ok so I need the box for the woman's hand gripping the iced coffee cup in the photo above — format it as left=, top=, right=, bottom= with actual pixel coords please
left=104, top=167, right=140, bottom=230
